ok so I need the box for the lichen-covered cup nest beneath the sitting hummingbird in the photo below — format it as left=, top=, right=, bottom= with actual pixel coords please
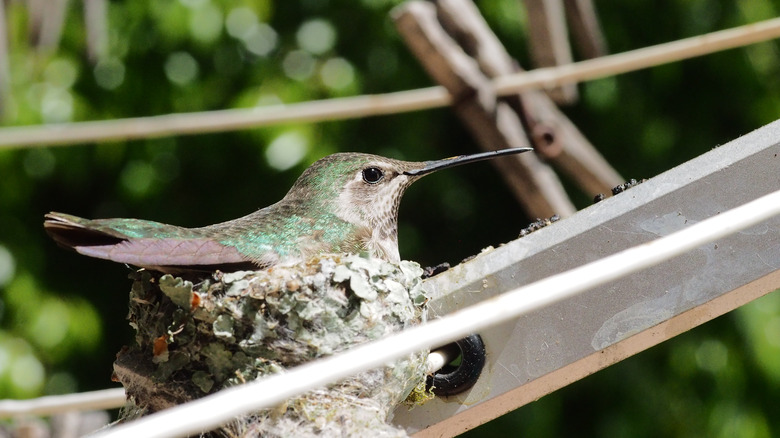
left=114, top=255, right=427, bottom=436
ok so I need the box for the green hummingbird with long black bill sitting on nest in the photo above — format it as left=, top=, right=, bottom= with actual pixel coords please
left=43, top=148, right=533, bottom=273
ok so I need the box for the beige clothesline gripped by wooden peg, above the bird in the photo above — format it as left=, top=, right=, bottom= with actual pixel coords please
left=0, top=18, right=780, bottom=149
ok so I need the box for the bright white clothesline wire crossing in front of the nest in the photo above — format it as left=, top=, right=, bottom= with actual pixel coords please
left=82, top=190, right=780, bottom=438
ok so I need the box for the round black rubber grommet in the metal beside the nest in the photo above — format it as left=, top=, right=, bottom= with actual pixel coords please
left=426, top=334, right=486, bottom=397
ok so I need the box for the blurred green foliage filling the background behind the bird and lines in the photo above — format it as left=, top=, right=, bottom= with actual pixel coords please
left=0, top=0, right=780, bottom=437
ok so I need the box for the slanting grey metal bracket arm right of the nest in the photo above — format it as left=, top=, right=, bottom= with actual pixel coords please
left=394, top=121, right=780, bottom=437
